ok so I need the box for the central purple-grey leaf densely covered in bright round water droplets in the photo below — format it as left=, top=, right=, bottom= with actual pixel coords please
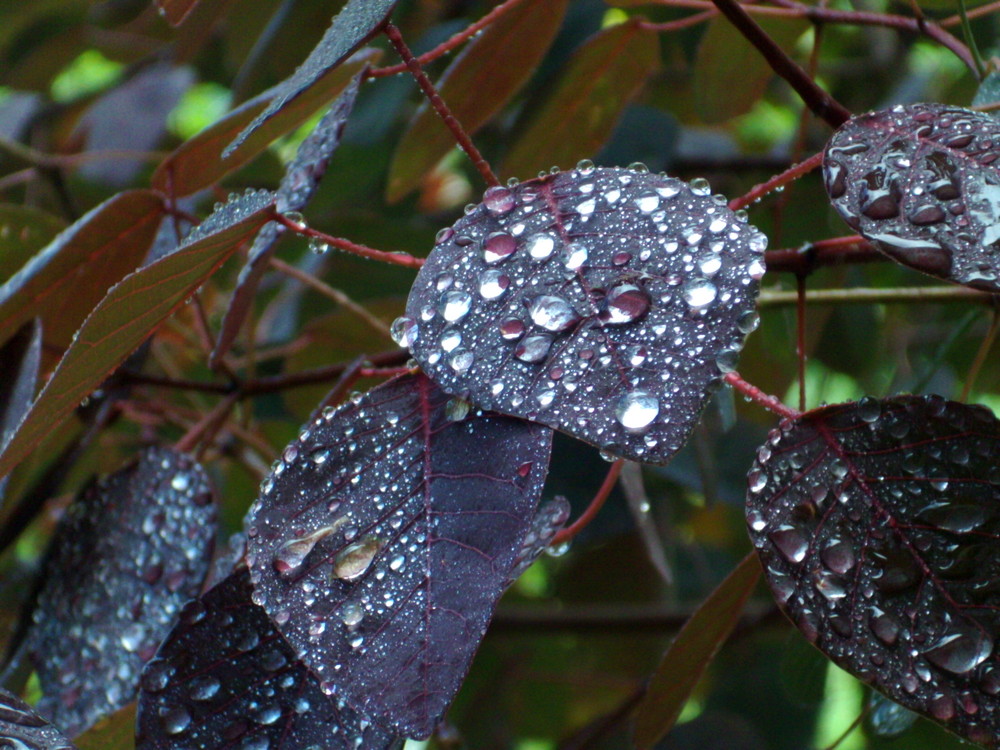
left=394, top=164, right=767, bottom=463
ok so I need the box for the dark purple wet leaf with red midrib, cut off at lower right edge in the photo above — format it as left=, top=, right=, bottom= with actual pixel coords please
left=747, top=396, right=1000, bottom=746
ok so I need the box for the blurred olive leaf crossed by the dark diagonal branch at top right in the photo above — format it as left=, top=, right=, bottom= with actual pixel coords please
left=692, top=15, right=809, bottom=124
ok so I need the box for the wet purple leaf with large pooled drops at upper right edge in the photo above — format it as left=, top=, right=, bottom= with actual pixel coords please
left=823, top=104, right=1000, bottom=292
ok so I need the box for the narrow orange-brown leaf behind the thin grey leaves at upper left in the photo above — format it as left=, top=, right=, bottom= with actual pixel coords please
left=152, top=49, right=381, bottom=201
